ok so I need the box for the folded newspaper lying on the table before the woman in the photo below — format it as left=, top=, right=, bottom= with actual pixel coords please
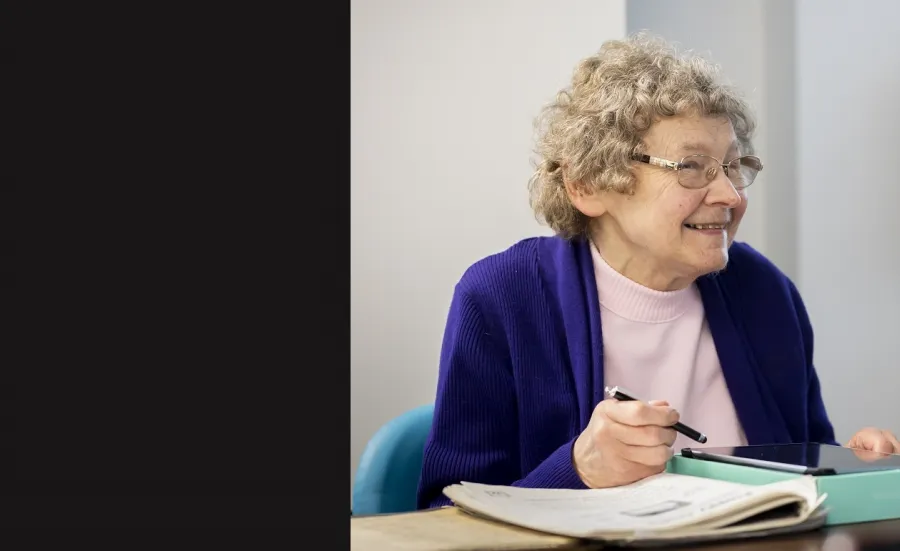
left=444, top=473, right=826, bottom=543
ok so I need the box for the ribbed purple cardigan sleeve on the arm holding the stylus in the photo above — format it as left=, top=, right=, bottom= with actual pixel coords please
left=418, top=287, right=585, bottom=508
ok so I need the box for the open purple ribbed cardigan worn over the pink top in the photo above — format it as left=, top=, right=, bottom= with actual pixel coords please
left=418, top=237, right=836, bottom=508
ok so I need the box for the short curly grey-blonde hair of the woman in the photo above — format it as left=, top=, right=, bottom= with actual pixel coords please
left=528, top=33, right=756, bottom=238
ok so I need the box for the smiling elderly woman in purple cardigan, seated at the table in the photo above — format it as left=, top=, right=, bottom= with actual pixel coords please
left=418, top=36, right=900, bottom=508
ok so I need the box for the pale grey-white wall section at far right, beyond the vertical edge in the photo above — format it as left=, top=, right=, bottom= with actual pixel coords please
left=796, top=0, right=900, bottom=440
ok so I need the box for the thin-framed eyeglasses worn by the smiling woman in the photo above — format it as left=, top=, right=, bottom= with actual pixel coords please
left=633, top=154, right=762, bottom=189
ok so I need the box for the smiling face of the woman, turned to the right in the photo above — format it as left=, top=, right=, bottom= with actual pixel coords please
left=573, top=116, right=747, bottom=290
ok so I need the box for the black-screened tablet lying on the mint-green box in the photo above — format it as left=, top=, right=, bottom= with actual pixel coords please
left=681, top=444, right=900, bottom=476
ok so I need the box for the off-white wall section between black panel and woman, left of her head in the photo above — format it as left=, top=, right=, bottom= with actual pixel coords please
left=352, top=0, right=625, bottom=484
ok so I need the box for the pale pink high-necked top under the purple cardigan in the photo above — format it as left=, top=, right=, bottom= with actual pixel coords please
left=591, top=242, right=747, bottom=453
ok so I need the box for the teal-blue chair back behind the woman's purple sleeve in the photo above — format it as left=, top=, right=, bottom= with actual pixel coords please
left=350, top=404, right=434, bottom=515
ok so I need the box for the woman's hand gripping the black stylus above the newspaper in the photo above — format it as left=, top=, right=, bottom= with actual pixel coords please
left=572, top=399, right=678, bottom=488
